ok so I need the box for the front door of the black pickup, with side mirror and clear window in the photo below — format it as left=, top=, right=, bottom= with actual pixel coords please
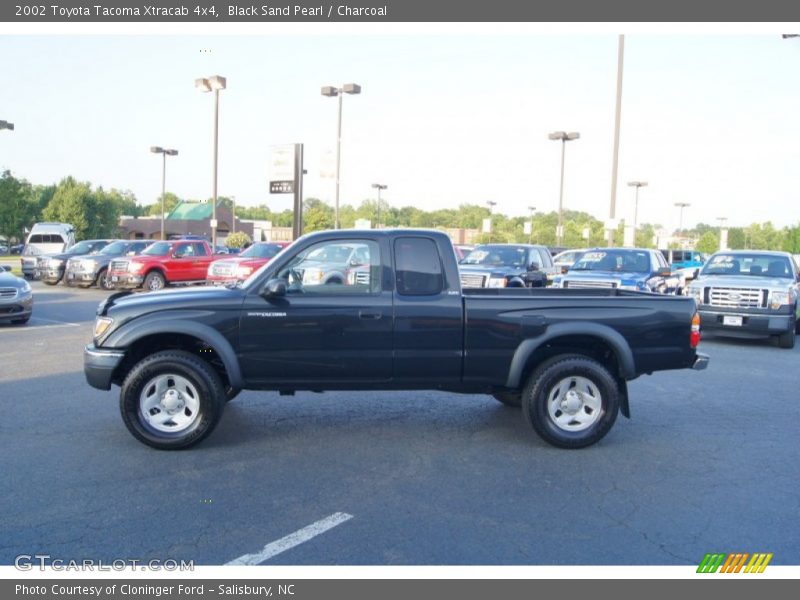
left=239, top=238, right=392, bottom=389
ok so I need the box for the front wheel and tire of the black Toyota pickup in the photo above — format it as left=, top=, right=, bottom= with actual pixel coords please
left=119, top=350, right=225, bottom=450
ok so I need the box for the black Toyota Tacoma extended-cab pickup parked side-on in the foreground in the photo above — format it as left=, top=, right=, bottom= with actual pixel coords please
left=84, top=230, right=708, bottom=449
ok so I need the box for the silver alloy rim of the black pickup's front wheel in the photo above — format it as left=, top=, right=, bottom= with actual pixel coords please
left=139, top=373, right=200, bottom=433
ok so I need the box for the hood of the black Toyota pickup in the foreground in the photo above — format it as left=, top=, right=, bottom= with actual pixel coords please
left=97, top=286, right=245, bottom=316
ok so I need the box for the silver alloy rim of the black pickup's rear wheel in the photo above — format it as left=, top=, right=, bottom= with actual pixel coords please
left=547, top=377, right=603, bottom=431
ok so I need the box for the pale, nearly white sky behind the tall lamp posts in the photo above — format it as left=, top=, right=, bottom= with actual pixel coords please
left=0, top=27, right=800, bottom=228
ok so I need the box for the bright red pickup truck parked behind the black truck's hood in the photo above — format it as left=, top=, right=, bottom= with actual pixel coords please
left=111, top=240, right=215, bottom=292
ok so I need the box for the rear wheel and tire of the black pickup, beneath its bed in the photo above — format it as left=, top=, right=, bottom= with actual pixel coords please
left=522, top=354, right=620, bottom=449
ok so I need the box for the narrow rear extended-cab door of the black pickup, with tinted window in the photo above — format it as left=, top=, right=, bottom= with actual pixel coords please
left=393, top=236, right=463, bottom=387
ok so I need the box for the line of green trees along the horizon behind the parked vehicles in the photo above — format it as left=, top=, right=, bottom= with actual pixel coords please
left=0, top=171, right=800, bottom=254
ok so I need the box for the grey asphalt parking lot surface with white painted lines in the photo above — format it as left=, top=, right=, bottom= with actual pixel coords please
left=0, top=282, right=800, bottom=565
